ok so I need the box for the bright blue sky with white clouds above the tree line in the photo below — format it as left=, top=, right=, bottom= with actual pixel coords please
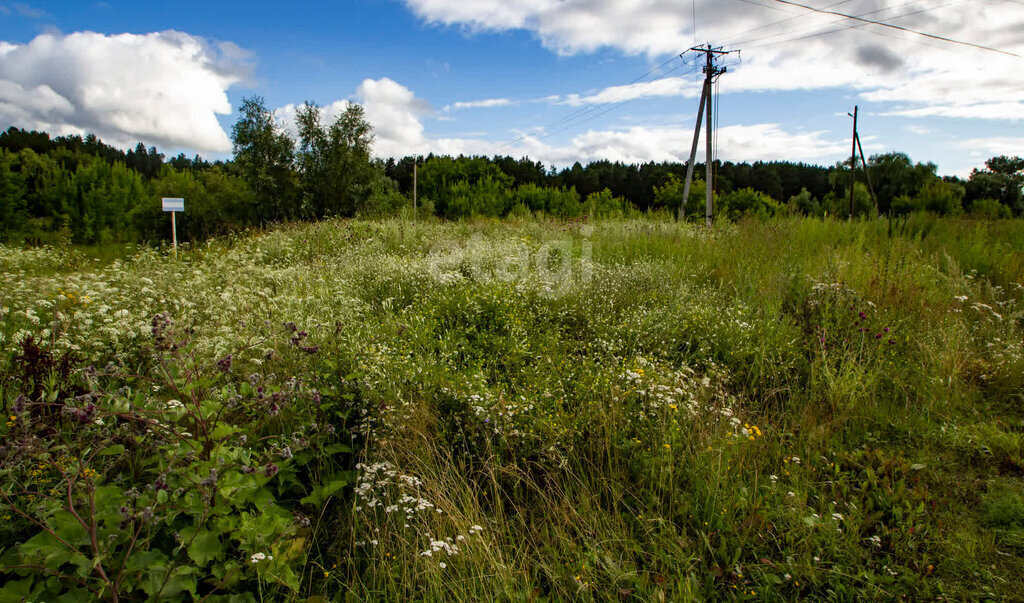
left=0, top=0, right=1024, bottom=175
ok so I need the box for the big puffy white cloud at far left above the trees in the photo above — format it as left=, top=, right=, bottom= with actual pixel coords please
left=0, top=31, right=251, bottom=153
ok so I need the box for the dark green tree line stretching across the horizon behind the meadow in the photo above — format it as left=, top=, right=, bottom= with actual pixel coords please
left=0, top=97, right=1024, bottom=244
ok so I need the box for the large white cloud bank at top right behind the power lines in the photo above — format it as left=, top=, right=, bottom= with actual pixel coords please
left=403, top=0, right=1024, bottom=119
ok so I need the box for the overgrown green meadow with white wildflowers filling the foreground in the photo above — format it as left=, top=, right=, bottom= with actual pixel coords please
left=0, top=215, right=1024, bottom=602
